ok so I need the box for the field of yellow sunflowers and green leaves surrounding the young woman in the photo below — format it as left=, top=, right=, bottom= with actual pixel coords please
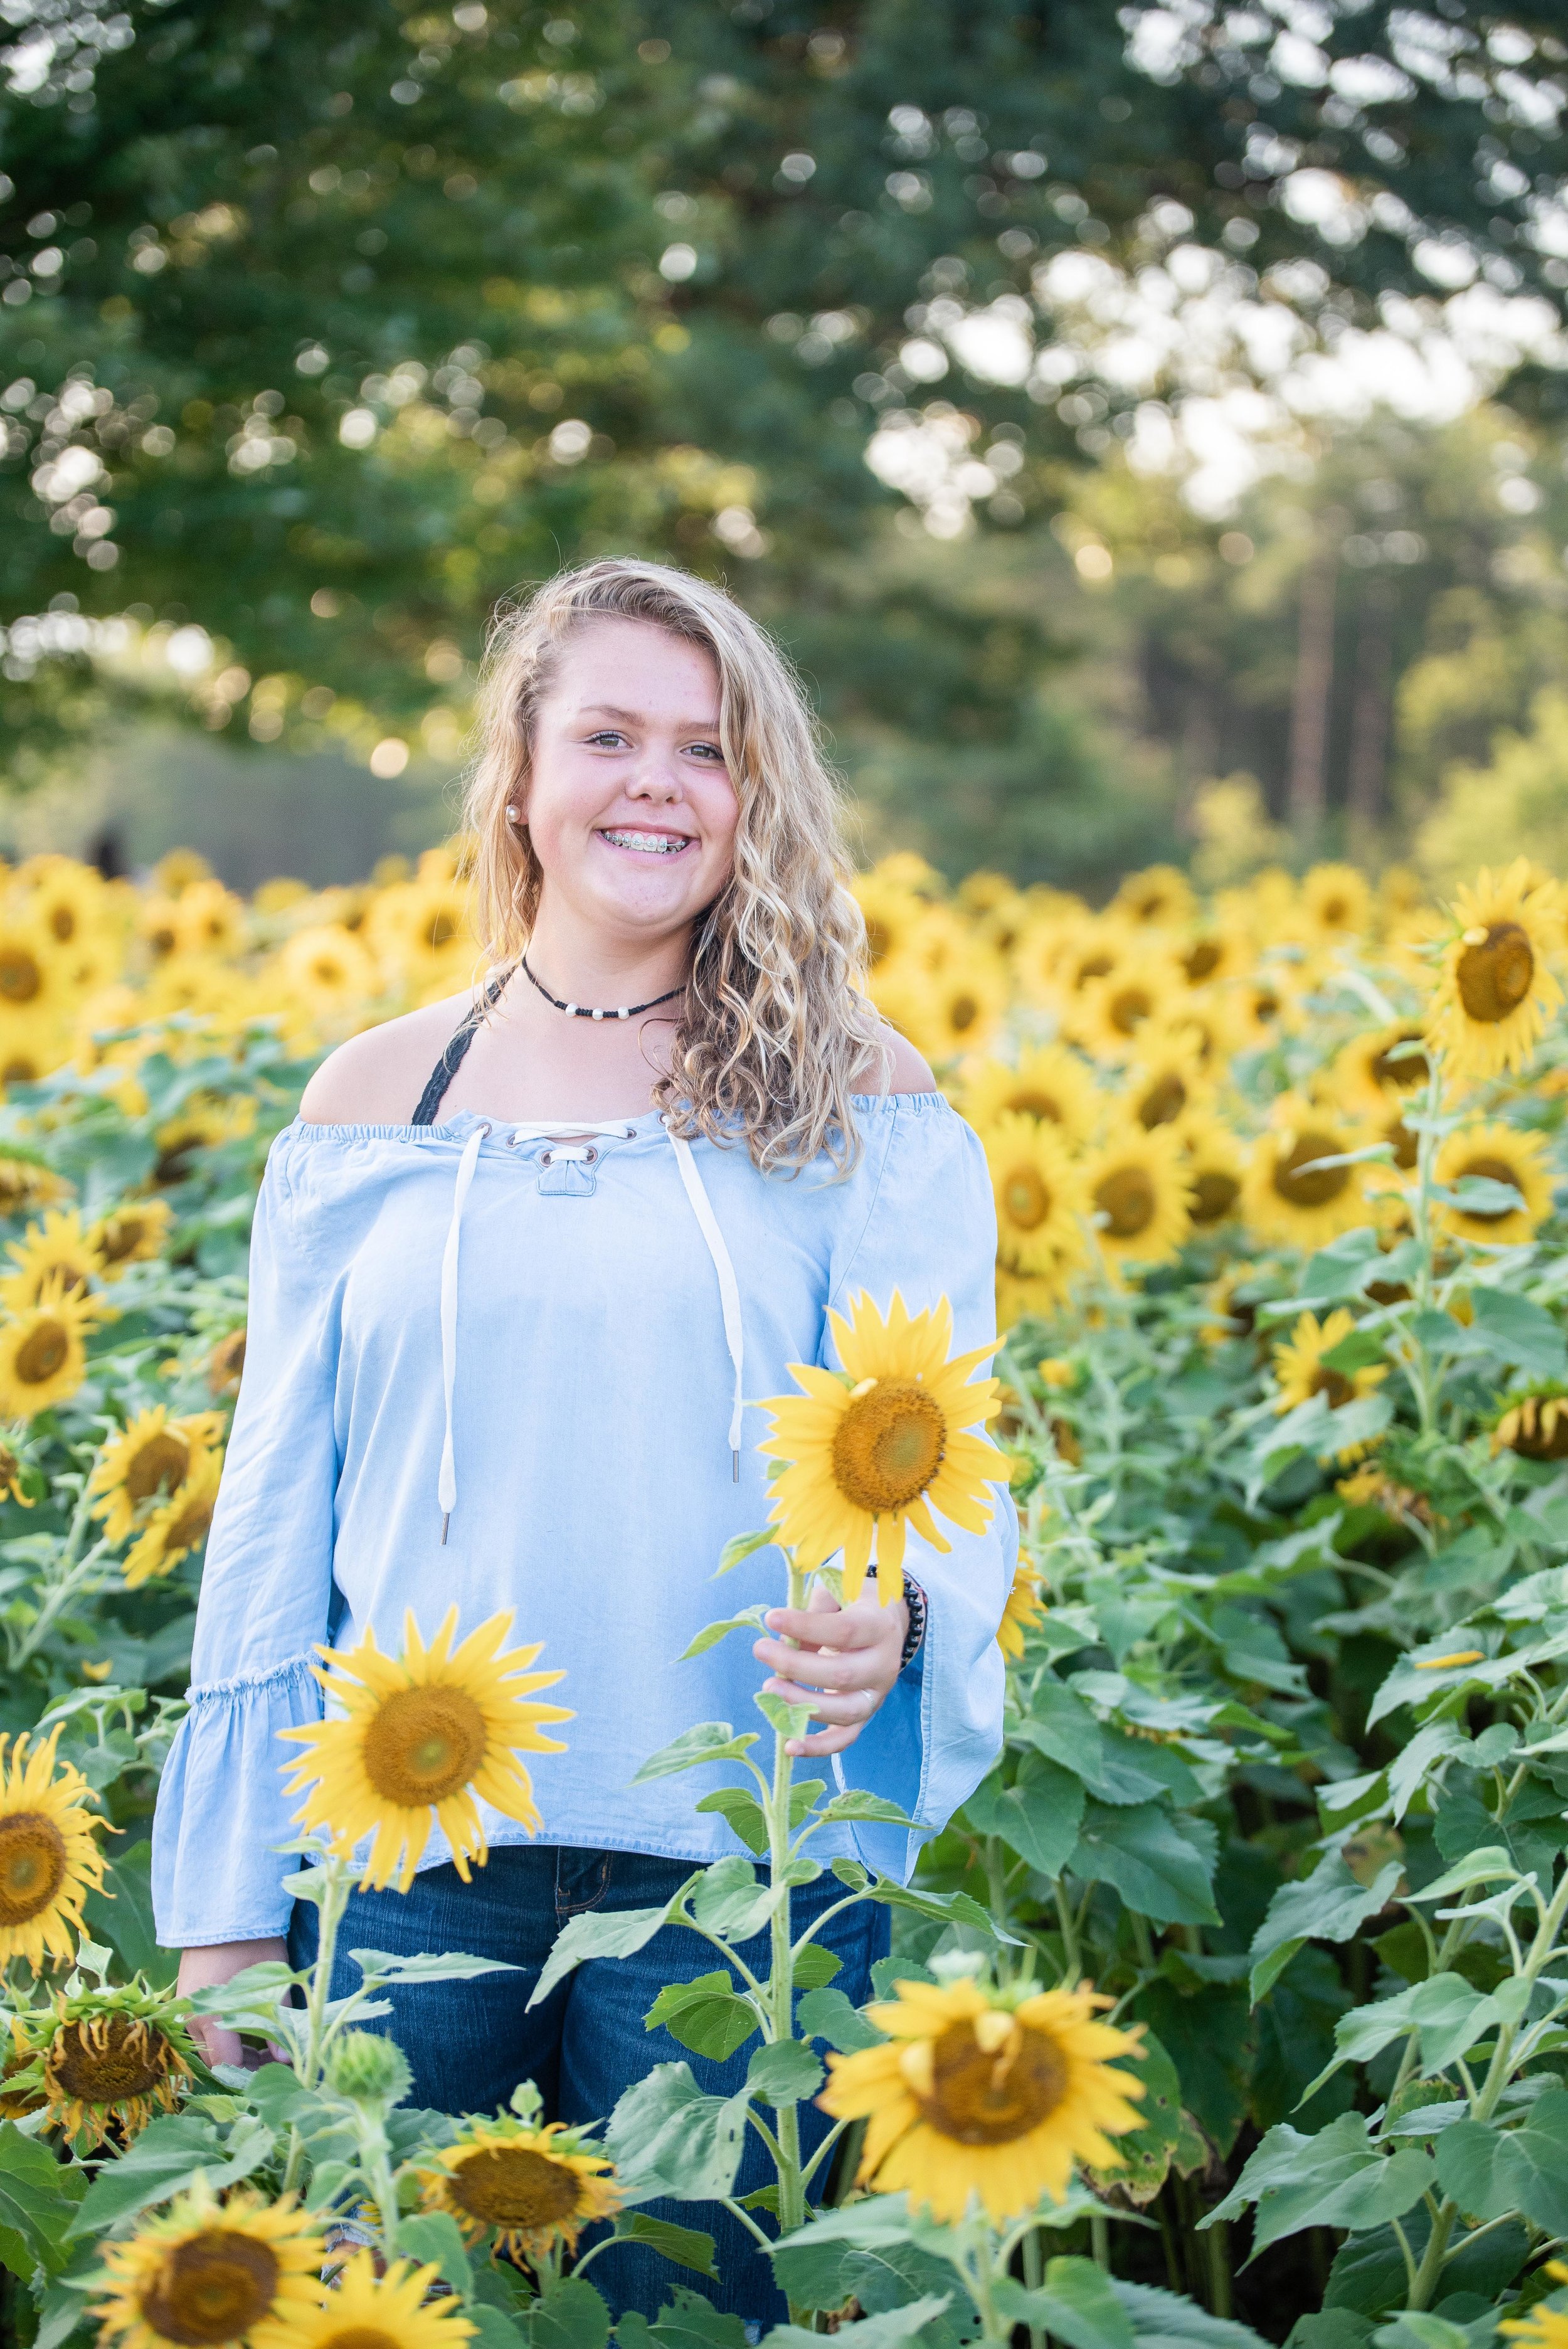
left=0, top=851, right=1568, bottom=2349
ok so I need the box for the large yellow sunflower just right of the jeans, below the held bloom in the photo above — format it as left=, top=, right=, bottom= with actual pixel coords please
left=817, top=1980, right=1143, bottom=2225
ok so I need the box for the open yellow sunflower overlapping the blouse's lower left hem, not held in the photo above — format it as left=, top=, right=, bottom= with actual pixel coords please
left=279, top=1607, right=573, bottom=1893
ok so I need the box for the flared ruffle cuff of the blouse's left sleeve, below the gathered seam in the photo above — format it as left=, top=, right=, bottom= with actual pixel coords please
left=152, top=1656, right=322, bottom=1949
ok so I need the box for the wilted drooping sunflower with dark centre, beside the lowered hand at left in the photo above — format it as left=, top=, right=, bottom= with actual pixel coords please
left=21, top=1976, right=195, bottom=2156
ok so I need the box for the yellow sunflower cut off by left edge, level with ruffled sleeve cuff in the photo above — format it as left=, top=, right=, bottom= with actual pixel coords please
left=0, top=1727, right=103, bottom=1973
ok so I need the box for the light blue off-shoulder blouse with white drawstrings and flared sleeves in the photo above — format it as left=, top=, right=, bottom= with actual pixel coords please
left=152, top=1092, right=1017, bottom=1948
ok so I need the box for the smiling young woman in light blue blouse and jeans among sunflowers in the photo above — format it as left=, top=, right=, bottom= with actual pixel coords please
left=155, top=561, right=1017, bottom=2318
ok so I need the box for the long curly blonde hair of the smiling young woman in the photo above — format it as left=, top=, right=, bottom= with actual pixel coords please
left=465, top=554, right=892, bottom=1175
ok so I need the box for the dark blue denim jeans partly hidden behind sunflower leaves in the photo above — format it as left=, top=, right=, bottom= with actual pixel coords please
left=289, top=1844, right=889, bottom=2328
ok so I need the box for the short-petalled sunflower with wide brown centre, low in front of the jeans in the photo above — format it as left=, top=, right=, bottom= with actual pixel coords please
left=420, top=2112, right=620, bottom=2260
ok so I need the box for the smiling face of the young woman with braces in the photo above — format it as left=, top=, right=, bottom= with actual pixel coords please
left=521, top=618, right=739, bottom=942
